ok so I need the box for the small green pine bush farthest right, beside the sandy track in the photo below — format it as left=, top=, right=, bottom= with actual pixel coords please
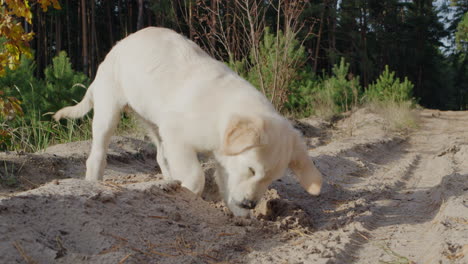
left=364, top=65, right=414, bottom=102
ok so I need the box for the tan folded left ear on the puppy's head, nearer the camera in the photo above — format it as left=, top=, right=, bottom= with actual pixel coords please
left=222, top=115, right=265, bottom=156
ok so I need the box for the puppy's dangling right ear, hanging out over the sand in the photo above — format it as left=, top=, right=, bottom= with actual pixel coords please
left=289, top=130, right=322, bottom=195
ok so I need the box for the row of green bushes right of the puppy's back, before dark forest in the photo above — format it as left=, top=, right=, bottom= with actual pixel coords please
left=228, top=29, right=417, bottom=130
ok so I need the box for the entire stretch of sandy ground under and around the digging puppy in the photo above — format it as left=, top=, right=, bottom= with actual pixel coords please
left=0, top=110, right=468, bottom=264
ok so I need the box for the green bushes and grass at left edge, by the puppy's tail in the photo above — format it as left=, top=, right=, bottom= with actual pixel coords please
left=0, top=52, right=91, bottom=152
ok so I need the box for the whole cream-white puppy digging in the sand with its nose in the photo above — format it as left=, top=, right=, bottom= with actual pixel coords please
left=54, top=27, right=322, bottom=216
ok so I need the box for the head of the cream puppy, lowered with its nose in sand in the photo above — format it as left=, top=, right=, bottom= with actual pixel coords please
left=216, top=115, right=322, bottom=216
